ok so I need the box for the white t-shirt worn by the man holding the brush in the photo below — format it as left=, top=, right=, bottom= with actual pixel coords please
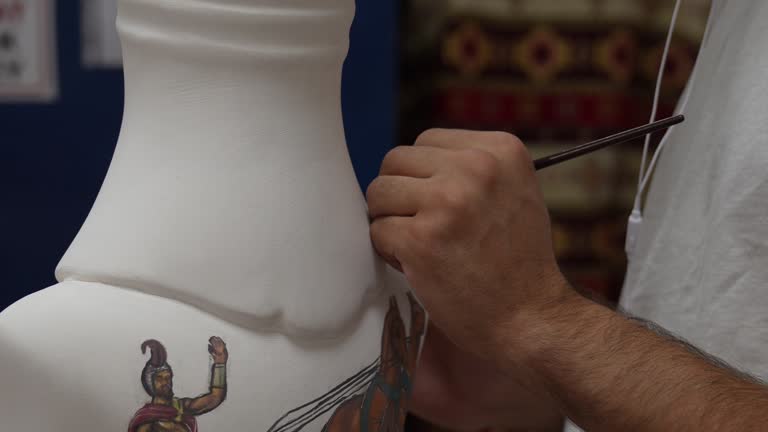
left=569, top=0, right=768, bottom=430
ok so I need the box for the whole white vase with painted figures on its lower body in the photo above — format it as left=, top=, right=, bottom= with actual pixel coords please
left=0, top=0, right=425, bottom=432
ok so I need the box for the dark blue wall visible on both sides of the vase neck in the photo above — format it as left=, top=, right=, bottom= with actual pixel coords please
left=0, top=0, right=397, bottom=311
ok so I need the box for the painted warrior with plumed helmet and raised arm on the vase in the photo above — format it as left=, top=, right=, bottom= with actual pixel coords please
left=128, top=337, right=229, bottom=432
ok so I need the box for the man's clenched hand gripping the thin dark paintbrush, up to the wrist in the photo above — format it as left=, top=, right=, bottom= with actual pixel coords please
left=367, top=130, right=571, bottom=366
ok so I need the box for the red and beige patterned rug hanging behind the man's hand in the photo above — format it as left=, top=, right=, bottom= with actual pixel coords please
left=400, top=0, right=709, bottom=299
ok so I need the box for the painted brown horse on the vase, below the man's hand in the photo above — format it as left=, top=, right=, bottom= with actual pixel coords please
left=323, top=295, right=426, bottom=432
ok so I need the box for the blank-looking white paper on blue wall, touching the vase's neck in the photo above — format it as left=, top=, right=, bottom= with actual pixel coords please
left=80, top=0, right=122, bottom=68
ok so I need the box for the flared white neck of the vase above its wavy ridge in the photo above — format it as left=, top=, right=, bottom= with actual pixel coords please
left=57, top=0, right=400, bottom=337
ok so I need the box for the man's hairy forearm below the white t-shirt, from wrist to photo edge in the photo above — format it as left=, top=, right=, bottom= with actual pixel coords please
left=510, top=296, right=768, bottom=432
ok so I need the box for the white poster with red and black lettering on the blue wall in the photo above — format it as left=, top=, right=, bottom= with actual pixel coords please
left=0, top=0, right=58, bottom=103
